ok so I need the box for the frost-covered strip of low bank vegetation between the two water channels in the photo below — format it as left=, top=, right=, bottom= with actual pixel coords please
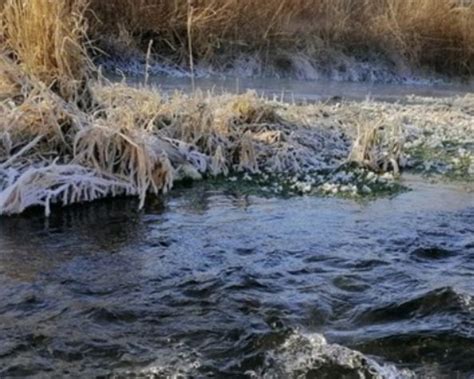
left=0, top=69, right=474, bottom=214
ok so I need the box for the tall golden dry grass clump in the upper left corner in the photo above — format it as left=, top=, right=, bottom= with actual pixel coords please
left=0, top=0, right=90, bottom=100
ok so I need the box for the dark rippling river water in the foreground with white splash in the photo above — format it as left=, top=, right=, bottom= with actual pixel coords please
left=0, top=177, right=474, bottom=378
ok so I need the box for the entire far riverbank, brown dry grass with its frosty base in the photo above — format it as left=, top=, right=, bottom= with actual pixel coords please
left=89, top=0, right=474, bottom=83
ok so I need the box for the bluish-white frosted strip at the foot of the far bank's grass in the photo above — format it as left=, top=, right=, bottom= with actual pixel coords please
left=97, top=53, right=443, bottom=85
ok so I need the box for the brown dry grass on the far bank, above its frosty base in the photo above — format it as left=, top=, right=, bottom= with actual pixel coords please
left=91, top=0, right=474, bottom=74
